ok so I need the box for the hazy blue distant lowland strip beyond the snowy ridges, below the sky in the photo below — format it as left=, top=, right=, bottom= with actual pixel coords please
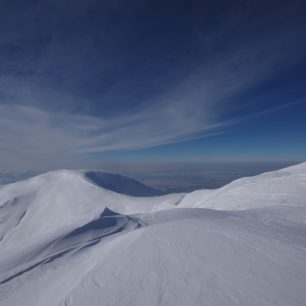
left=0, top=161, right=302, bottom=193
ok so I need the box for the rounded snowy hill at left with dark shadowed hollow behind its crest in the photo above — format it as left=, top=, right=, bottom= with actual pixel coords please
left=0, top=170, right=182, bottom=245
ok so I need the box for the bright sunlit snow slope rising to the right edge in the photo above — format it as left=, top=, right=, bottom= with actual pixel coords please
left=180, top=163, right=306, bottom=210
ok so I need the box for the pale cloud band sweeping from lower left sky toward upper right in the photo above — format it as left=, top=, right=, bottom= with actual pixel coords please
left=0, top=3, right=303, bottom=168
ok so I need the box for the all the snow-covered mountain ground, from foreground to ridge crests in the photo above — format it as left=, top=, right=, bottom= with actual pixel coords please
left=0, top=163, right=306, bottom=306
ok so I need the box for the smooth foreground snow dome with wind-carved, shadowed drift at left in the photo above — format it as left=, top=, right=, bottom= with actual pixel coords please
left=0, top=208, right=306, bottom=306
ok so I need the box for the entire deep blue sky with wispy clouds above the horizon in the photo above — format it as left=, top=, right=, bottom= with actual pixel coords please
left=0, top=0, right=306, bottom=169
